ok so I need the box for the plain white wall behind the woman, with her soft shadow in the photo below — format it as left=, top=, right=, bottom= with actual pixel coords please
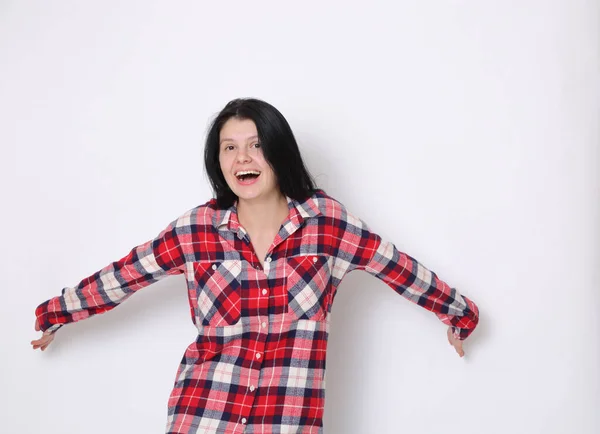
left=0, top=0, right=600, bottom=434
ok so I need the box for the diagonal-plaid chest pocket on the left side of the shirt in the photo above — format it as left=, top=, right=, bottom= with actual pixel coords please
left=194, top=260, right=242, bottom=327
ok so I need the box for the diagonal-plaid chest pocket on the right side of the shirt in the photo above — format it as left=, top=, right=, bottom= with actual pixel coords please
left=286, top=255, right=332, bottom=321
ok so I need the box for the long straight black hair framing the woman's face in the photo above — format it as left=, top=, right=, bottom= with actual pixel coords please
left=204, top=98, right=316, bottom=208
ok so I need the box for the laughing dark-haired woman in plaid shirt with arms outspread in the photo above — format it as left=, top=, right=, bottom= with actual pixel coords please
left=32, top=99, right=478, bottom=433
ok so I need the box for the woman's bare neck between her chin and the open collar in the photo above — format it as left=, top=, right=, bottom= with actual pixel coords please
left=237, top=191, right=288, bottom=231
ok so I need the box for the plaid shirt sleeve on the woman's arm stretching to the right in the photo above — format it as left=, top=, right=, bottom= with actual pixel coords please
left=334, top=206, right=479, bottom=340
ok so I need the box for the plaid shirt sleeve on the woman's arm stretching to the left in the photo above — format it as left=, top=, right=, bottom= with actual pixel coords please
left=35, top=220, right=185, bottom=332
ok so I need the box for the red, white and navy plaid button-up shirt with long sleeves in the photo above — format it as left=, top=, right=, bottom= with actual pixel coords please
left=36, top=190, right=478, bottom=434
